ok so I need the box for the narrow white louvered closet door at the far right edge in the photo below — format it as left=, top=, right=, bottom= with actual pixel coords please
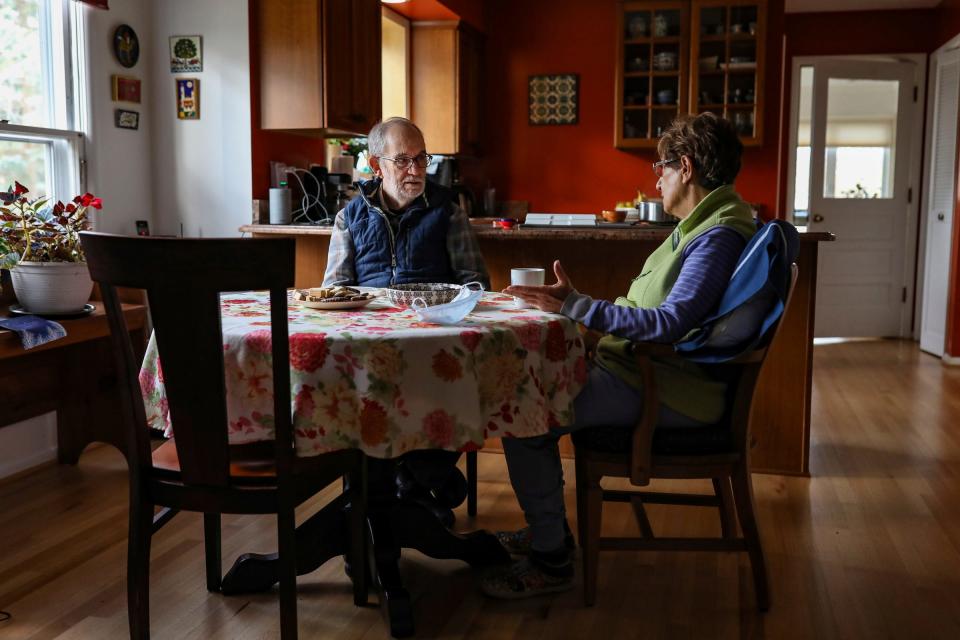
left=920, top=49, right=960, bottom=356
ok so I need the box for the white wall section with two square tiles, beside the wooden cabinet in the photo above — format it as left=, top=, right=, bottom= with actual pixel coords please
left=150, top=0, right=252, bottom=237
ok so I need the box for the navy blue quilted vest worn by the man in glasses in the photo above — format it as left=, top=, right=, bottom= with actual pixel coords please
left=343, top=180, right=454, bottom=287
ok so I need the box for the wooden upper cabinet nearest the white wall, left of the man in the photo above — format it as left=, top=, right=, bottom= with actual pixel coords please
left=255, top=0, right=381, bottom=136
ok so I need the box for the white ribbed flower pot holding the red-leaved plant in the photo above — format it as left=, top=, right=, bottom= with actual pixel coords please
left=10, top=262, right=93, bottom=313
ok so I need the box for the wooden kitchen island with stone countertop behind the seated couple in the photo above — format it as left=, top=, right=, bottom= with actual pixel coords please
left=240, top=221, right=834, bottom=475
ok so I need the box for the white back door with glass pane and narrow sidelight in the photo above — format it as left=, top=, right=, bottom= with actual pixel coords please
left=794, top=59, right=919, bottom=336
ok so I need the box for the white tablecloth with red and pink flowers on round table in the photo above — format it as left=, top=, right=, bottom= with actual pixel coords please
left=140, top=292, right=587, bottom=458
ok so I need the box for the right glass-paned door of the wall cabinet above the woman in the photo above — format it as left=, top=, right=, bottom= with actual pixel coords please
left=690, top=0, right=767, bottom=146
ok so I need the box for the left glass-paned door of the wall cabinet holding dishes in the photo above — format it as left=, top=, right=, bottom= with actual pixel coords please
left=615, top=0, right=690, bottom=148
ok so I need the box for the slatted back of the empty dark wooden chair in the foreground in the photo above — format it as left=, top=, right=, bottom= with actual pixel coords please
left=81, top=232, right=295, bottom=487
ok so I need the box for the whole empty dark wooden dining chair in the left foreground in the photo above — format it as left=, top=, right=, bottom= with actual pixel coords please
left=81, top=233, right=368, bottom=639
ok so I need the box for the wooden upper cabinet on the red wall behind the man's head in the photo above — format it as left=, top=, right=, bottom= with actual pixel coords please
left=410, top=22, right=483, bottom=156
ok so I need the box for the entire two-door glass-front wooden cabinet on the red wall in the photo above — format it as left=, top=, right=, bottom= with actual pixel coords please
left=614, top=0, right=767, bottom=149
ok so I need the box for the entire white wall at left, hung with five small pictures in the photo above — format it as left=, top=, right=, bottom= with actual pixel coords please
left=0, top=0, right=252, bottom=478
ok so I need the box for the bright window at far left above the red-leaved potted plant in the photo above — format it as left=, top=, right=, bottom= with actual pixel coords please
left=0, top=0, right=83, bottom=200
